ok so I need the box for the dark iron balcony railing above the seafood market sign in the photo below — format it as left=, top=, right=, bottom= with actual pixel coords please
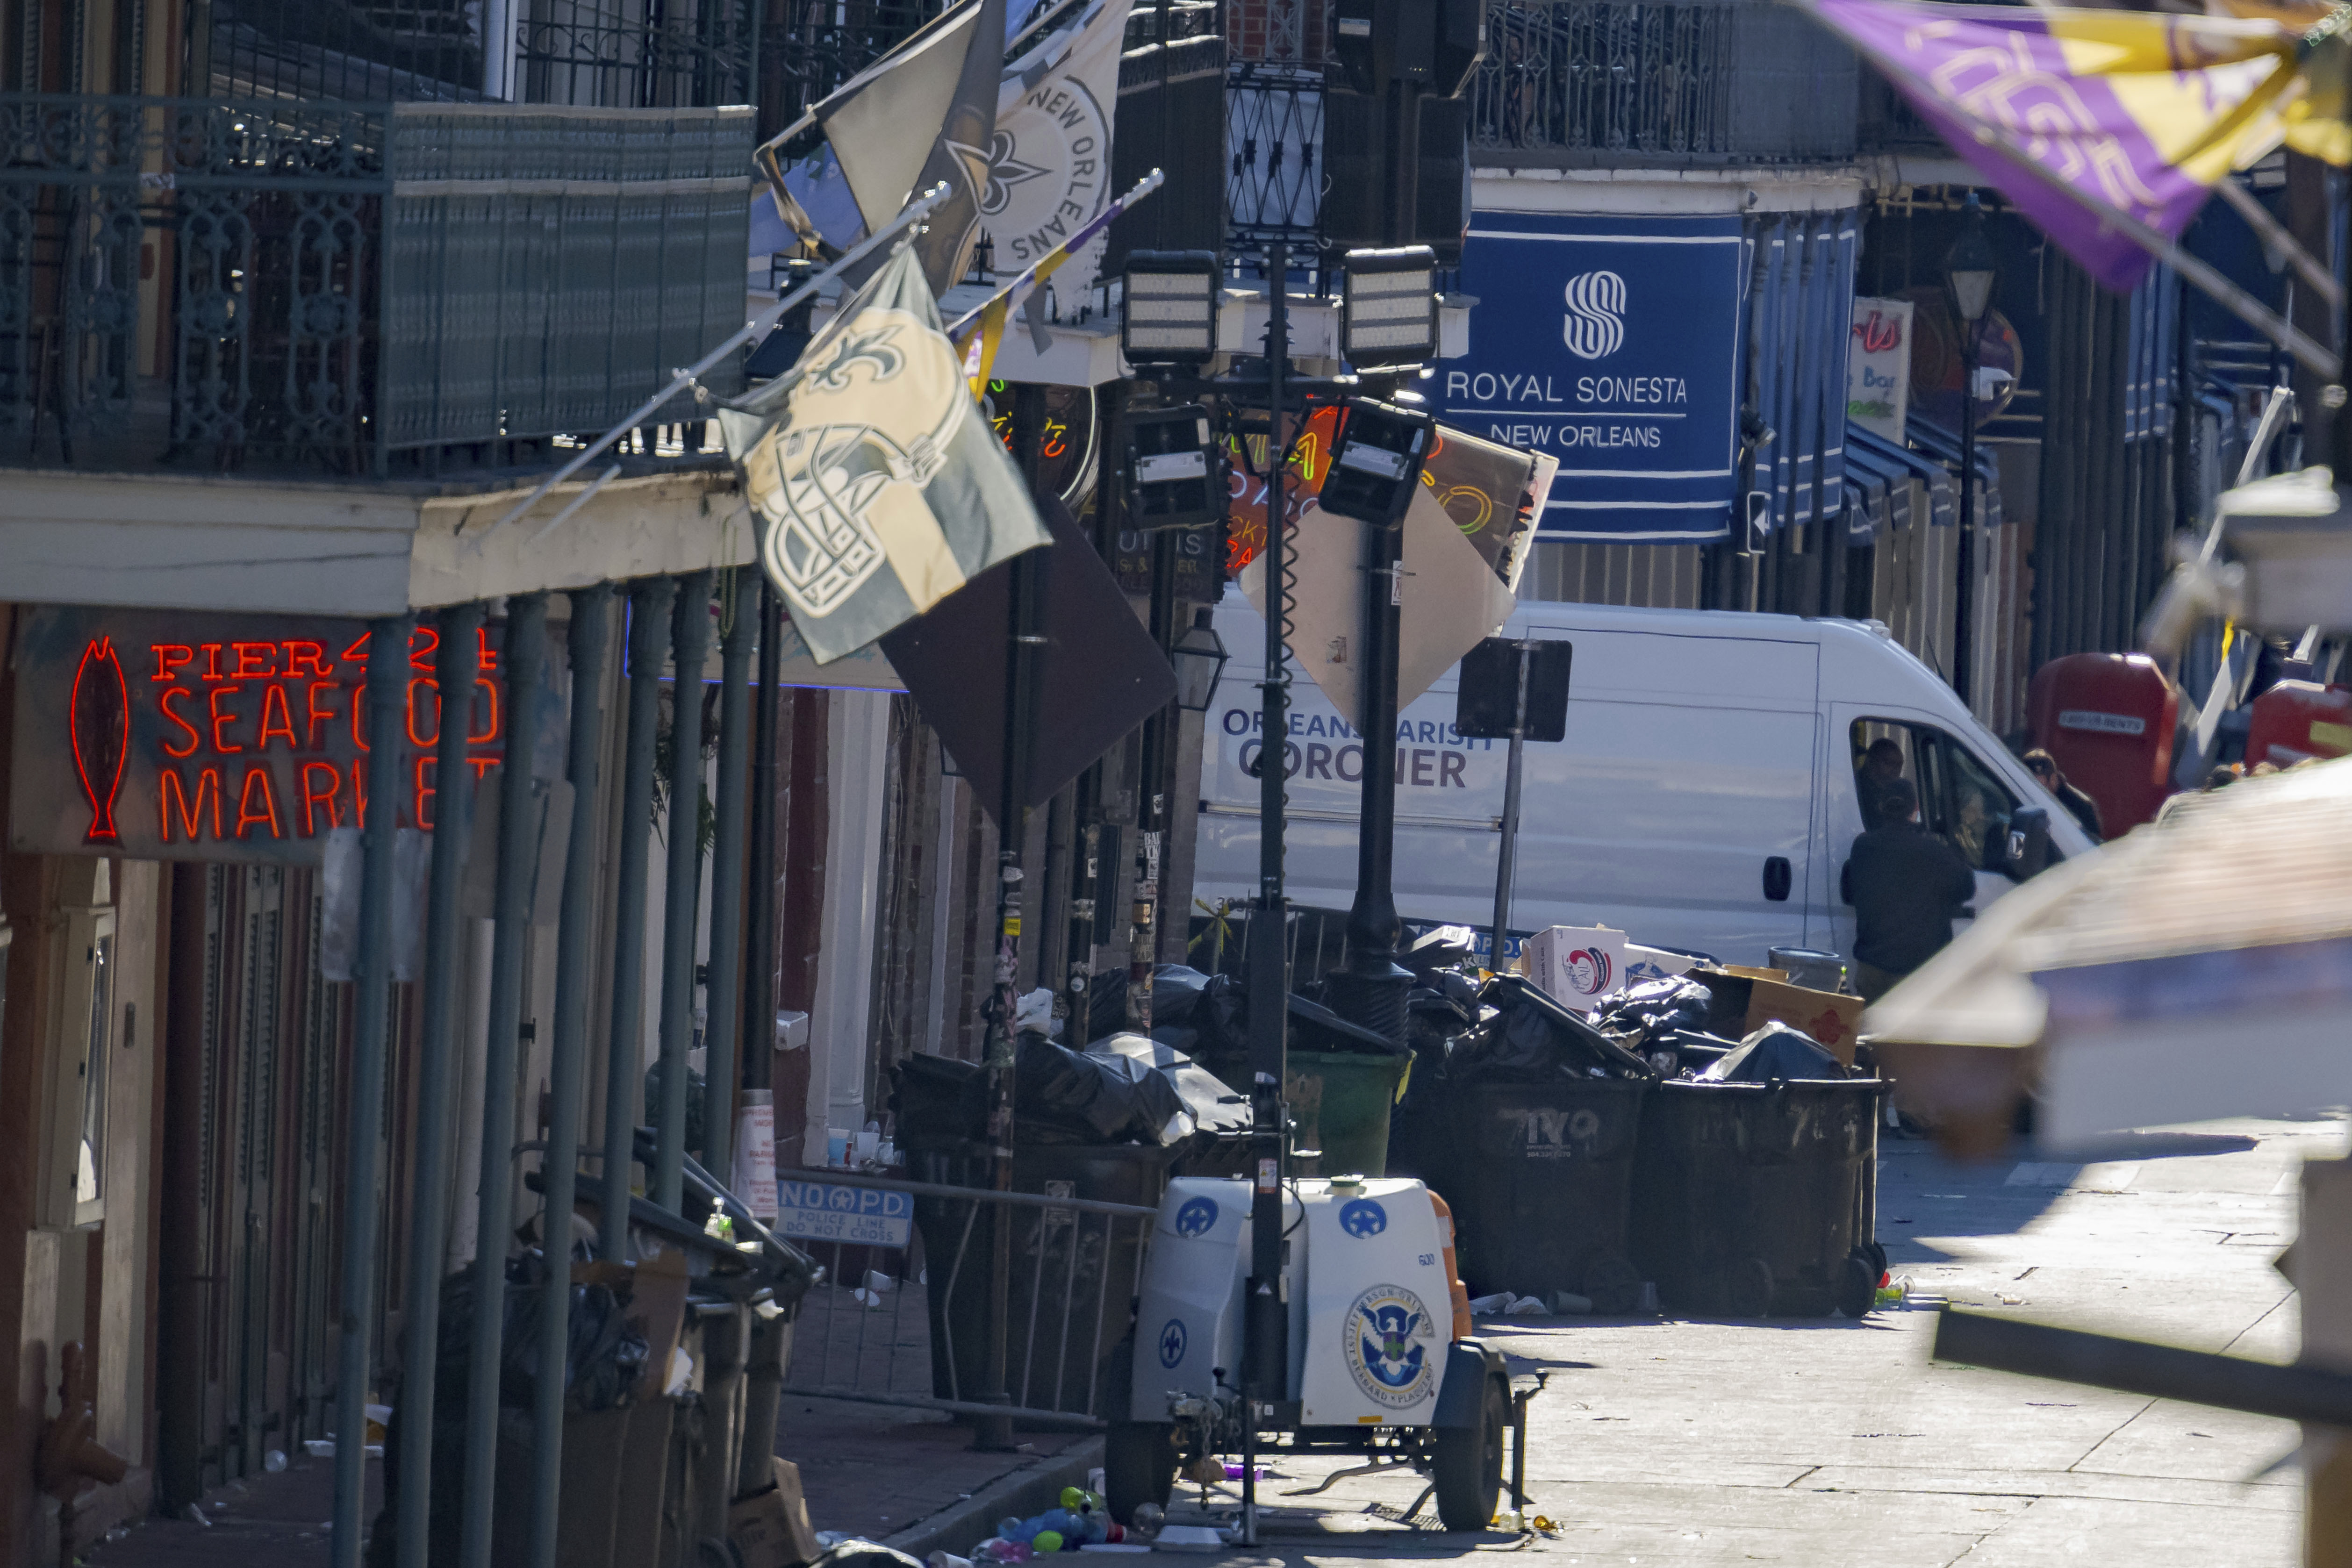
left=0, top=94, right=753, bottom=477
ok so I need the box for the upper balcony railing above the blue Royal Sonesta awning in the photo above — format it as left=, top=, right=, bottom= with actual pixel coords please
left=1468, top=0, right=1858, bottom=167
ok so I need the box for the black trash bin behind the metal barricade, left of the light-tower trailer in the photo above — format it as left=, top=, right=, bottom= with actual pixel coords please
left=908, top=1143, right=1181, bottom=1413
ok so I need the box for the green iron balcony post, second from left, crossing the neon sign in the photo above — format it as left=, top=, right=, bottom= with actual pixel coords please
left=395, top=600, right=485, bottom=1568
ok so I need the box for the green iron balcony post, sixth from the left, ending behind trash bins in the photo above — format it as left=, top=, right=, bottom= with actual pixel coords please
left=654, top=569, right=710, bottom=1213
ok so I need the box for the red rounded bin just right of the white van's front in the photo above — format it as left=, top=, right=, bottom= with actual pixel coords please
left=2025, top=653, right=2180, bottom=839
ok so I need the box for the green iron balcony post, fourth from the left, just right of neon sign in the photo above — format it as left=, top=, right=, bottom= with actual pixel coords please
left=529, top=583, right=611, bottom=1568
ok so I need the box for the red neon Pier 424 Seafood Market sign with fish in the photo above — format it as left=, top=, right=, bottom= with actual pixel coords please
left=9, top=607, right=506, bottom=865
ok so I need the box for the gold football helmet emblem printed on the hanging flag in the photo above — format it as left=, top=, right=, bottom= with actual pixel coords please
left=743, top=308, right=969, bottom=616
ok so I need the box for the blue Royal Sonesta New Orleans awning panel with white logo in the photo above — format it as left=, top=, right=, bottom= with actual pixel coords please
left=1440, top=212, right=1748, bottom=543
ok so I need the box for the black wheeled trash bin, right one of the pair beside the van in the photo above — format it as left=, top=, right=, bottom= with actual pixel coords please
left=1632, top=1079, right=1886, bottom=1317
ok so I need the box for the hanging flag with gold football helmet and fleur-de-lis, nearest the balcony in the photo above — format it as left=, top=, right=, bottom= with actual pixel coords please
left=720, top=247, right=1049, bottom=663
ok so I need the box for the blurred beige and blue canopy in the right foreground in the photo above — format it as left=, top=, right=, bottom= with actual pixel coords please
left=1863, top=759, right=2352, bottom=1143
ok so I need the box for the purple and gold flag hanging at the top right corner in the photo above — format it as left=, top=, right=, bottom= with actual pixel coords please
left=1797, top=0, right=2347, bottom=289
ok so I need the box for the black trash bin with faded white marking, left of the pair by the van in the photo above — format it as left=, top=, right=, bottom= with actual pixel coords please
left=1420, top=1077, right=1649, bottom=1314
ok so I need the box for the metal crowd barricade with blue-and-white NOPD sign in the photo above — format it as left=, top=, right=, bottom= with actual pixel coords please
left=779, top=1171, right=1157, bottom=1427
